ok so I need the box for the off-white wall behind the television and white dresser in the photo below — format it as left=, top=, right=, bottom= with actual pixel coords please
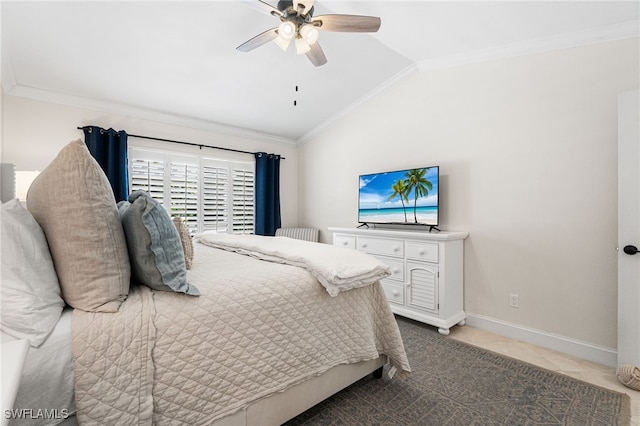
left=299, top=39, right=639, bottom=350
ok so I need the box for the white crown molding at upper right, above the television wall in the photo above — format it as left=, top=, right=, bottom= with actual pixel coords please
left=418, top=20, right=640, bottom=71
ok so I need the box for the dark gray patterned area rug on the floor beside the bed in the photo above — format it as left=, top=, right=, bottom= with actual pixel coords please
left=286, top=317, right=630, bottom=426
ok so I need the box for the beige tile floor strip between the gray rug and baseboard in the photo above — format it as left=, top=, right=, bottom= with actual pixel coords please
left=449, top=325, right=640, bottom=426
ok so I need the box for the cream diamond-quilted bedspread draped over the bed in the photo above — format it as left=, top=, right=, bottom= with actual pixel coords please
left=72, top=243, right=410, bottom=425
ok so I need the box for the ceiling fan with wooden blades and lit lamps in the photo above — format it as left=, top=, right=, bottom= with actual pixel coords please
left=236, top=0, right=380, bottom=67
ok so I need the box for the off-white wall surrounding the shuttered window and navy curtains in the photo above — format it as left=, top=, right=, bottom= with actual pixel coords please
left=2, top=94, right=298, bottom=226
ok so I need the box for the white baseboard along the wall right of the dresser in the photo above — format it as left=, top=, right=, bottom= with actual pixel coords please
left=467, top=312, right=618, bottom=368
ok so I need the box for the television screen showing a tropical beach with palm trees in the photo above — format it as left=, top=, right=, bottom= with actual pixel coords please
left=358, top=166, right=438, bottom=225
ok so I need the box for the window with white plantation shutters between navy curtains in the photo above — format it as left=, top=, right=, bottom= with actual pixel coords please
left=129, top=148, right=255, bottom=234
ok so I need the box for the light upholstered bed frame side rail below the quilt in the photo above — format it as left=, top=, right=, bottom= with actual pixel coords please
left=61, top=355, right=387, bottom=426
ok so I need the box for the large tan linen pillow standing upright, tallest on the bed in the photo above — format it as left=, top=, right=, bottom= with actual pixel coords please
left=27, top=140, right=131, bottom=312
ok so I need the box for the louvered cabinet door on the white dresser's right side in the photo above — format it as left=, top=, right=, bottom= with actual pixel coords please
left=406, top=262, right=438, bottom=314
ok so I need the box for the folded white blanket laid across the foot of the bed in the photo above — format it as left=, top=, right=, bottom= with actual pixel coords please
left=196, top=233, right=390, bottom=296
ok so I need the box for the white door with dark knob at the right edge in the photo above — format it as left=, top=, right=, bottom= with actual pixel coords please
left=618, top=90, right=640, bottom=367
